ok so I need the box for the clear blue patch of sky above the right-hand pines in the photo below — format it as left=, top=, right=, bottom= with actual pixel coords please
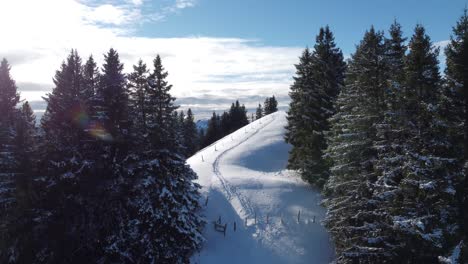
left=137, top=0, right=468, bottom=53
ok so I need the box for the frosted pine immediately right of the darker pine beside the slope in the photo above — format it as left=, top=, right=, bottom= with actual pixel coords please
left=324, top=27, right=387, bottom=263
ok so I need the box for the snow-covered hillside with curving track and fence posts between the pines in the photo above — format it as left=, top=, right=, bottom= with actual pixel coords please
left=188, top=112, right=333, bottom=264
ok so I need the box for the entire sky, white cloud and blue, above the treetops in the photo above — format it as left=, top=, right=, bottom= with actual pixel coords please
left=0, top=0, right=467, bottom=117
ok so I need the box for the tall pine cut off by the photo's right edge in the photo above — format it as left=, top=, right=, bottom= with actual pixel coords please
left=443, top=8, right=468, bottom=262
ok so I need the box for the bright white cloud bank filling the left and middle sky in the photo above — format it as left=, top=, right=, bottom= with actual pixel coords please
left=0, top=0, right=302, bottom=118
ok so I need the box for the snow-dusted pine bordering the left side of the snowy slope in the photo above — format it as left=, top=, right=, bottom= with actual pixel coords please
left=112, top=56, right=203, bottom=263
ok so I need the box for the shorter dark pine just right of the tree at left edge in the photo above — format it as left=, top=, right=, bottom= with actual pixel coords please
left=0, top=102, right=41, bottom=263
